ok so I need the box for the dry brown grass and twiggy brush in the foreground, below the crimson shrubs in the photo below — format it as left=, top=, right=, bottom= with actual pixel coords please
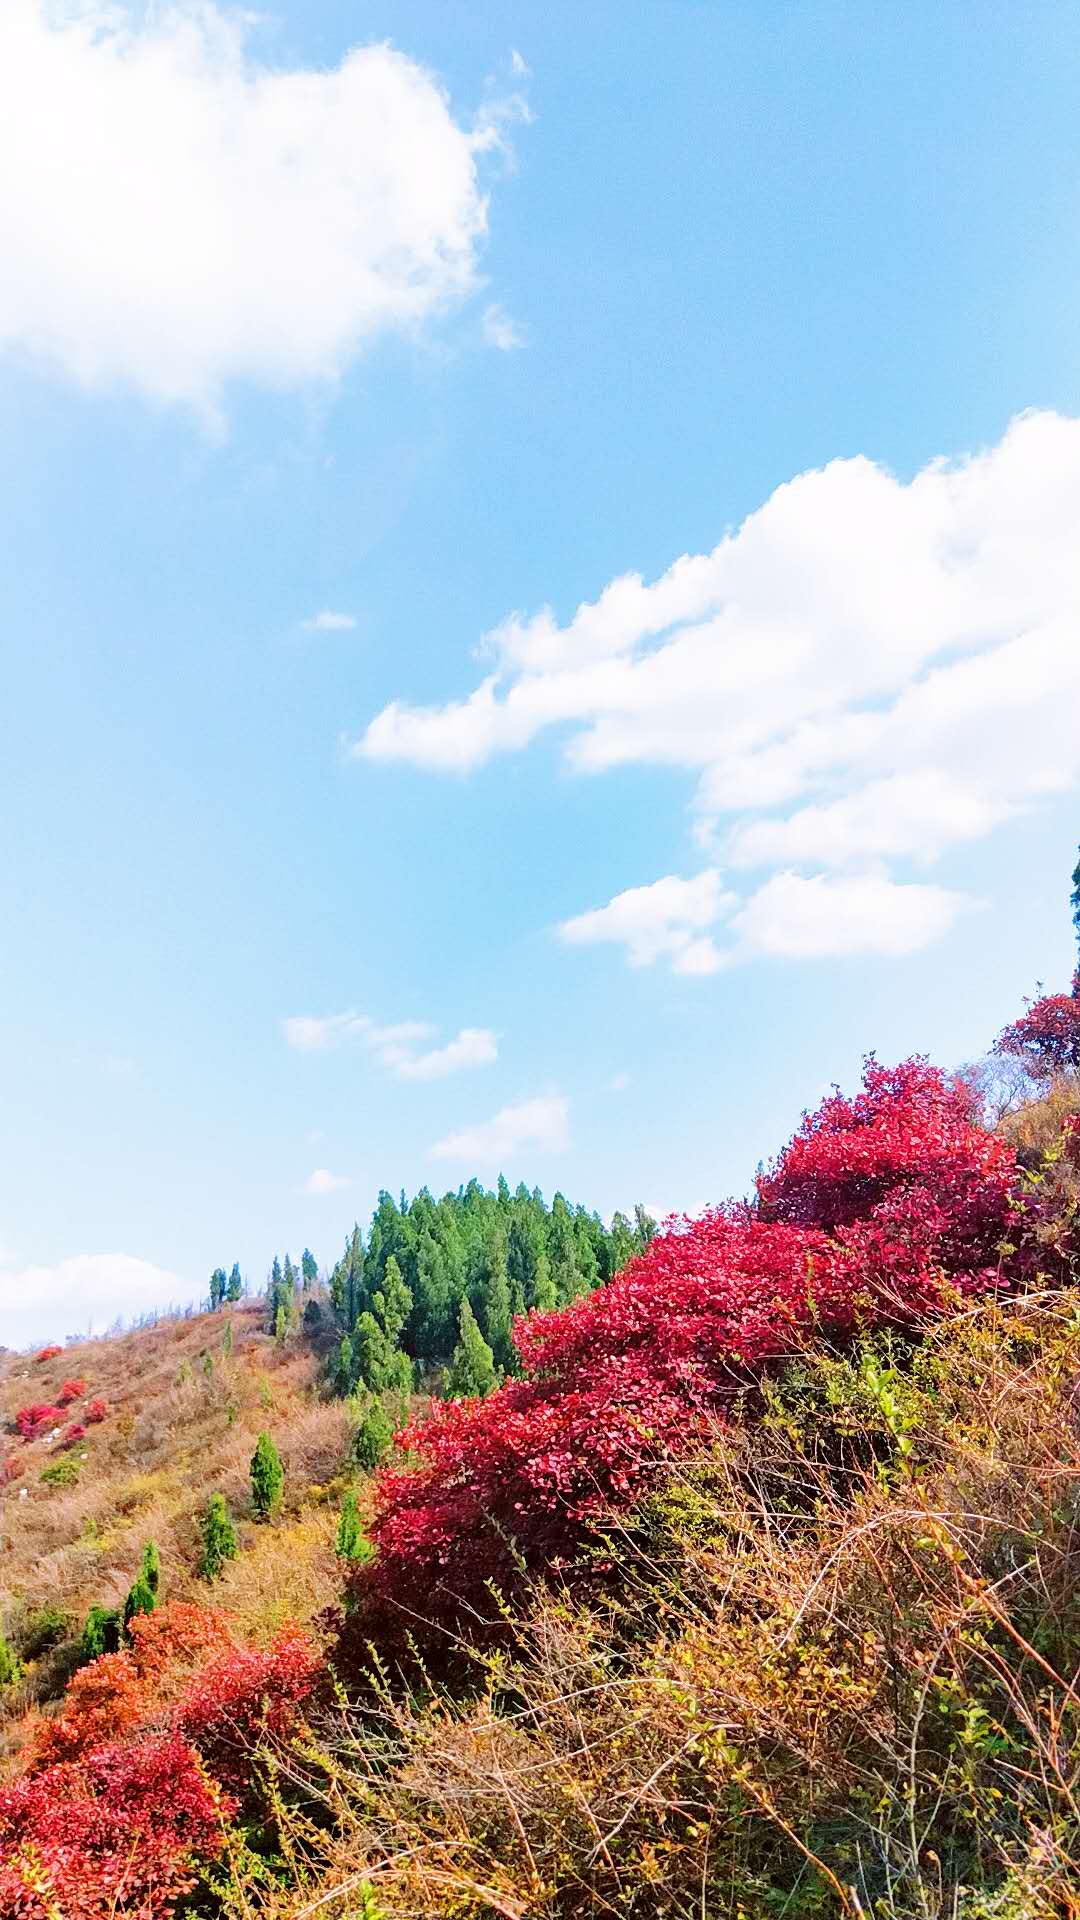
left=214, top=1294, right=1080, bottom=1920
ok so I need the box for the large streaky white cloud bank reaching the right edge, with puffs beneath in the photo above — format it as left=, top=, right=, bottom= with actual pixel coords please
left=354, top=413, right=1080, bottom=972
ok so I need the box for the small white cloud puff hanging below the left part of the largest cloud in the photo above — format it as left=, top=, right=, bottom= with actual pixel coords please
left=559, top=868, right=738, bottom=973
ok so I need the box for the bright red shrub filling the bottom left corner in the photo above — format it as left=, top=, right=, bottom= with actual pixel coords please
left=0, top=1735, right=231, bottom=1920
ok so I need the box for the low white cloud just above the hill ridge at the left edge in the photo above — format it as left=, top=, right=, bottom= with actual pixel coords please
left=0, top=1254, right=198, bottom=1348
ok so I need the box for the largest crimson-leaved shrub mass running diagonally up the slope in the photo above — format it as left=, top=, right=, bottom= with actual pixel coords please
left=342, top=1060, right=1017, bottom=1665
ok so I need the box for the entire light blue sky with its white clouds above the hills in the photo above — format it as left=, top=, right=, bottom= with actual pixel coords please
left=0, top=0, right=1080, bottom=1344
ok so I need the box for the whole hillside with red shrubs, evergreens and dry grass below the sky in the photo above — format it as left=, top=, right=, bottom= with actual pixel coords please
left=0, top=925, right=1080, bottom=1920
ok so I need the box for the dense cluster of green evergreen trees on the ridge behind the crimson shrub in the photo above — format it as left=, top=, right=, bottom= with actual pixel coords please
left=322, top=1179, right=655, bottom=1398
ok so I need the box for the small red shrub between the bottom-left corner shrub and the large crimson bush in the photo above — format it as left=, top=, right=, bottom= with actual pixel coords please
left=177, top=1626, right=327, bottom=1789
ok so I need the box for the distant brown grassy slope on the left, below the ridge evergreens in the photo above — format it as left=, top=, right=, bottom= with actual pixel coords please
left=0, top=1300, right=345, bottom=1747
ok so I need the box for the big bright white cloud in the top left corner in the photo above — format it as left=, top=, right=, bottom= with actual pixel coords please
left=0, top=0, right=500, bottom=415
